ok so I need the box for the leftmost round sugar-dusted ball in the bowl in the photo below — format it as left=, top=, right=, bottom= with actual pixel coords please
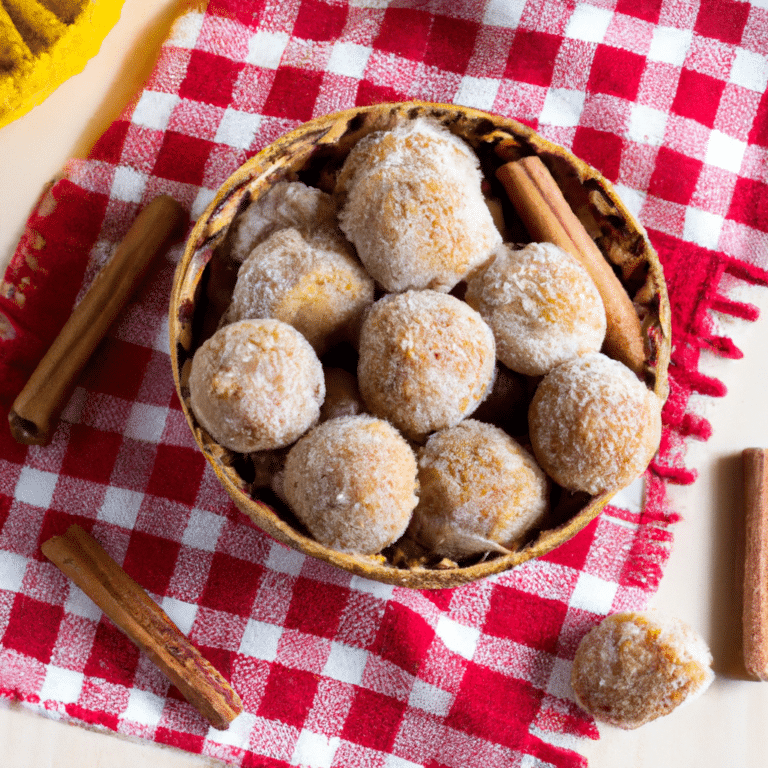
left=189, top=320, right=325, bottom=453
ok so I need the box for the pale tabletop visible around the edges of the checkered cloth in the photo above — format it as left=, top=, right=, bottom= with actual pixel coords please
left=0, top=0, right=768, bottom=768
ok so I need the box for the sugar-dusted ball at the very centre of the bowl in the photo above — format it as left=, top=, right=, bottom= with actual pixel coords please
left=357, top=290, right=496, bottom=439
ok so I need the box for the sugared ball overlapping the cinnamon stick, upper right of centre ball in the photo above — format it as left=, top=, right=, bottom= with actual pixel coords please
left=465, top=243, right=606, bottom=376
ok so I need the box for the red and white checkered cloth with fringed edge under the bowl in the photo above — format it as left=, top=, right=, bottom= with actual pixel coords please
left=0, top=0, right=768, bottom=768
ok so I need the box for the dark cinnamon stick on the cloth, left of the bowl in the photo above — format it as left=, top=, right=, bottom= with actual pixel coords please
left=8, top=195, right=184, bottom=445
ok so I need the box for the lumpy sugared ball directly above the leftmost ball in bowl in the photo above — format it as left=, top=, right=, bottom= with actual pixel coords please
left=226, top=228, right=374, bottom=355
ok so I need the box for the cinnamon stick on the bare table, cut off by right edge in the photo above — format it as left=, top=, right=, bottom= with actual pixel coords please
left=742, top=448, right=768, bottom=680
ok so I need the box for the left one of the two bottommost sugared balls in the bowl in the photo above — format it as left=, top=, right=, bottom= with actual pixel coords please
left=283, top=414, right=418, bottom=555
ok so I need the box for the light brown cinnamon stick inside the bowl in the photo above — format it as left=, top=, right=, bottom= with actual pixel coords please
left=496, top=155, right=645, bottom=375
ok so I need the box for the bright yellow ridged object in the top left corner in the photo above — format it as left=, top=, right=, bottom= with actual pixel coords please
left=0, top=0, right=123, bottom=127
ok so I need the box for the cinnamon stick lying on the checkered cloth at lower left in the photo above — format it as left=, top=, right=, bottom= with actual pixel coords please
left=42, top=525, right=242, bottom=730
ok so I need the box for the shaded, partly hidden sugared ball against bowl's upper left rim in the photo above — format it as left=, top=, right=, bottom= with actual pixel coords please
left=230, top=181, right=338, bottom=262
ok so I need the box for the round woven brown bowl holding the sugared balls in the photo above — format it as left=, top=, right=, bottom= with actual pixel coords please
left=170, top=102, right=670, bottom=589
